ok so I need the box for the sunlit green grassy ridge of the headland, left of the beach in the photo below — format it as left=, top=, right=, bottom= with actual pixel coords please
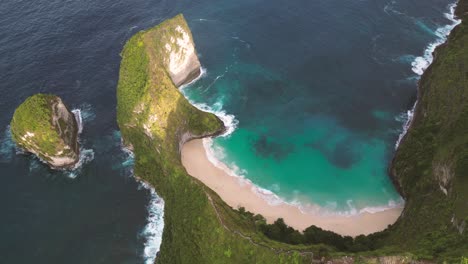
left=117, top=15, right=329, bottom=264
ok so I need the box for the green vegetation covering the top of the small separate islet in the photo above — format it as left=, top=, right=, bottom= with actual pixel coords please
left=10, top=94, right=62, bottom=158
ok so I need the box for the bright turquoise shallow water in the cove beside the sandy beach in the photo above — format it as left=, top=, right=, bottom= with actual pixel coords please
left=183, top=65, right=402, bottom=213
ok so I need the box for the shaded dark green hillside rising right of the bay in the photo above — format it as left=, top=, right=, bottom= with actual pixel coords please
left=387, top=0, right=468, bottom=262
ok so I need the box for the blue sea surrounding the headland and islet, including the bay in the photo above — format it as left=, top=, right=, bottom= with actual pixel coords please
left=0, top=0, right=458, bottom=264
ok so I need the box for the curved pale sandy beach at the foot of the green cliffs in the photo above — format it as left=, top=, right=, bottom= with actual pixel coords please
left=182, top=139, right=403, bottom=236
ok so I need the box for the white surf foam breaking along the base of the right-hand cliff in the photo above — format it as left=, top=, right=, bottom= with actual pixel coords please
left=395, top=3, right=461, bottom=149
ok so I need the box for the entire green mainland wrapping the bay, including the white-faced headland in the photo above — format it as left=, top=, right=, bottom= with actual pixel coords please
left=117, top=5, right=468, bottom=263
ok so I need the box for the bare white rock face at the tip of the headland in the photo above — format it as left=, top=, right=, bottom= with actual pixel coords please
left=164, top=26, right=201, bottom=86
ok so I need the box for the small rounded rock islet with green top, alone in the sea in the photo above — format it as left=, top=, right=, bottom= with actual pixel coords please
left=10, top=94, right=79, bottom=169
